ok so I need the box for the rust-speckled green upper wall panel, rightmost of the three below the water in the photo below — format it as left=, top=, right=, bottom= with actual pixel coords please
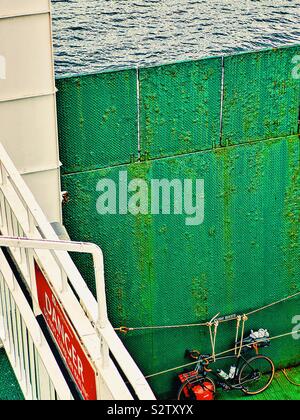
left=222, top=46, right=300, bottom=145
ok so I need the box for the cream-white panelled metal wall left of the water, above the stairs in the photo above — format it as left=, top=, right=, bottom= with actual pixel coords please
left=0, top=0, right=61, bottom=222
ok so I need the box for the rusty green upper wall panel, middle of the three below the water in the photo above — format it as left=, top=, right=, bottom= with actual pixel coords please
left=140, top=58, right=222, bottom=159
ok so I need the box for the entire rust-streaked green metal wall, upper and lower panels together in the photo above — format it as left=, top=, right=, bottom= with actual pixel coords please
left=57, top=47, right=300, bottom=397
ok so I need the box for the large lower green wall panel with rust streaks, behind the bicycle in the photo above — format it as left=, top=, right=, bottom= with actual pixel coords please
left=62, top=136, right=300, bottom=397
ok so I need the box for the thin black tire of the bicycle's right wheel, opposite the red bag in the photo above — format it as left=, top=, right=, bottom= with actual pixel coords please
left=238, top=355, right=275, bottom=395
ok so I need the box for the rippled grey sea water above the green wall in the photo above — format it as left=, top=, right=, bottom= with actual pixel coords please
left=52, top=0, right=300, bottom=74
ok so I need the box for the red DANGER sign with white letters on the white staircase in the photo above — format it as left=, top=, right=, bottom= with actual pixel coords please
left=35, top=264, right=97, bottom=400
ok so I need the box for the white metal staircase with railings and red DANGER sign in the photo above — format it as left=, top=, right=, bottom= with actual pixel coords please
left=0, top=144, right=155, bottom=400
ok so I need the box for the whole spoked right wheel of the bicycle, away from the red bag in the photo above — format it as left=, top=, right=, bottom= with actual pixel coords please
left=239, top=356, right=275, bottom=395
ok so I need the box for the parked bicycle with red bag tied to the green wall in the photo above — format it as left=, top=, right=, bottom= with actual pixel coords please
left=177, top=339, right=275, bottom=400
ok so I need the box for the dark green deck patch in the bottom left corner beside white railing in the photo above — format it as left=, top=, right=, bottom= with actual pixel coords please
left=0, top=349, right=24, bottom=401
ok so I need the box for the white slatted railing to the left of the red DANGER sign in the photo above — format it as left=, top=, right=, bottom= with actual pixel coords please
left=0, top=250, right=73, bottom=400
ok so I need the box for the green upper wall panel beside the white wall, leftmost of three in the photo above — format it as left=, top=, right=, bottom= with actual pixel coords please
left=56, top=70, right=138, bottom=173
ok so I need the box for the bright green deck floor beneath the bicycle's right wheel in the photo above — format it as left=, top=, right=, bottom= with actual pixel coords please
left=217, top=366, right=300, bottom=401
